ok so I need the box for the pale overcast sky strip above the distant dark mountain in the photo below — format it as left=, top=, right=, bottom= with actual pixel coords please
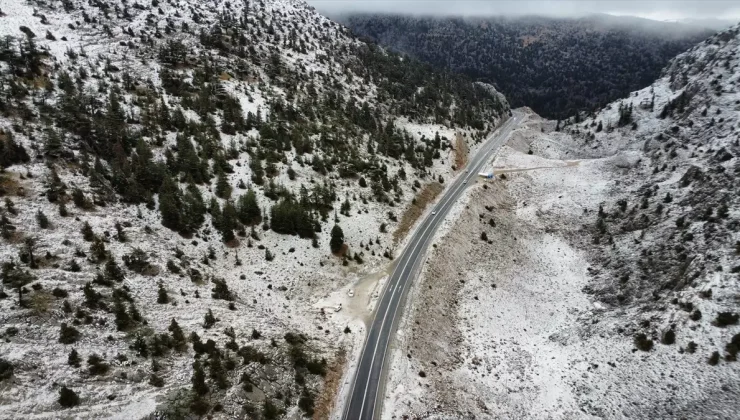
left=307, top=0, right=740, bottom=20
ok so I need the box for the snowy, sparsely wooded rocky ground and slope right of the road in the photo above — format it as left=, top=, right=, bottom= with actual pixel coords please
left=383, top=26, right=740, bottom=420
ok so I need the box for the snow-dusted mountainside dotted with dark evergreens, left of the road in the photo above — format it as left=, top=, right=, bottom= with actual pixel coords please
left=0, top=0, right=508, bottom=419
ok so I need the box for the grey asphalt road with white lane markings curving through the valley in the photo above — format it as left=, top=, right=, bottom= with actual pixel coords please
left=343, top=111, right=522, bottom=420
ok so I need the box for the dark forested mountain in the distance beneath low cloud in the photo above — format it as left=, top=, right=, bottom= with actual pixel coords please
left=342, top=15, right=713, bottom=119
